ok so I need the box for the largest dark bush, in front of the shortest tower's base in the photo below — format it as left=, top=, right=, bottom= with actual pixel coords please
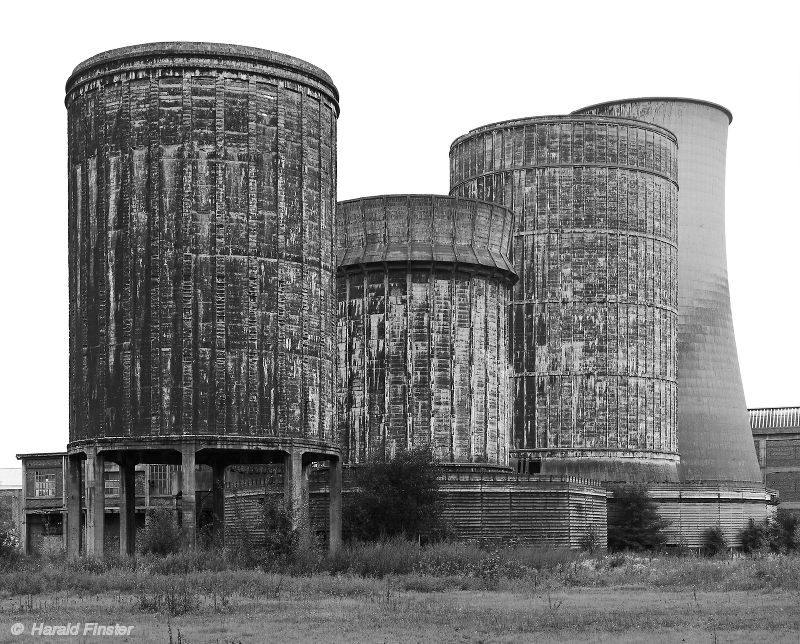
left=343, top=448, right=444, bottom=541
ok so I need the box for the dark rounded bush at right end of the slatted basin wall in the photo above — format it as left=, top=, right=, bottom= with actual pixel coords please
left=608, top=485, right=668, bottom=551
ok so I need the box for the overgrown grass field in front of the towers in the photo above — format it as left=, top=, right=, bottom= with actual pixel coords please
left=0, top=539, right=800, bottom=643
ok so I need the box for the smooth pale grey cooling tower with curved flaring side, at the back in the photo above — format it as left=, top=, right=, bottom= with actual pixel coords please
left=578, top=98, right=761, bottom=483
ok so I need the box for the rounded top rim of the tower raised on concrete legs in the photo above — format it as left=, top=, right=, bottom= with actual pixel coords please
left=66, top=42, right=339, bottom=114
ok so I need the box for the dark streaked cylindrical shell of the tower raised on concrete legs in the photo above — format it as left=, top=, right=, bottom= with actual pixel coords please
left=66, top=43, right=339, bottom=442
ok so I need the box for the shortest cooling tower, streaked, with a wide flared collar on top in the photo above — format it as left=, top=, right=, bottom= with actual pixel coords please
left=337, top=195, right=515, bottom=465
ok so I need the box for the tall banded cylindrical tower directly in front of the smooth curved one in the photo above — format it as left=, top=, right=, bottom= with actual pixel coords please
left=450, top=116, right=678, bottom=481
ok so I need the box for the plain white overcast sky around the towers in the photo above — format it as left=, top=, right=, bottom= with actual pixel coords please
left=0, top=0, right=800, bottom=467
